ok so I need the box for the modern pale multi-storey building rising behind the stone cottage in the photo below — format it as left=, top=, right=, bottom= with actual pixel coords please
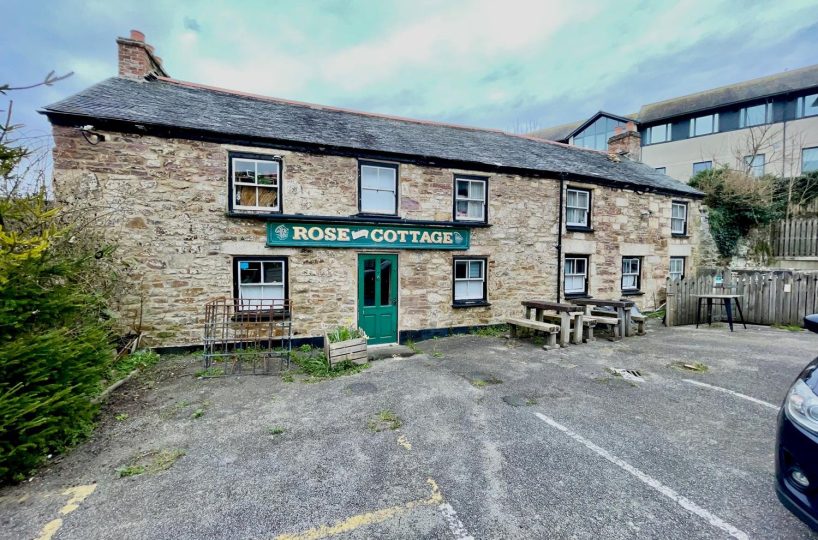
left=532, top=65, right=818, bottom=180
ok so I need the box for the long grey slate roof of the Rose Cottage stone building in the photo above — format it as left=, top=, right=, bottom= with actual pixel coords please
left=42, top=77, right=701, bottom=197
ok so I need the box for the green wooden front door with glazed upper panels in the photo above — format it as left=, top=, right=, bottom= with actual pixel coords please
left=358, top=255, right=398, bottom=345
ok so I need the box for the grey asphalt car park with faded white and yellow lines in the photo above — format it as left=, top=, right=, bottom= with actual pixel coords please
left=0, top=325, right=818, bottom=539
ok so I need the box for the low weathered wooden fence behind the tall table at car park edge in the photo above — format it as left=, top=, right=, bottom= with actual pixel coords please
left=666, top=270, right=818, bottom=326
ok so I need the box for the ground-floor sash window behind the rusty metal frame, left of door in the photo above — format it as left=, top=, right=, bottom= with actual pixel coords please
left=233, top=257, right=287, bottom=309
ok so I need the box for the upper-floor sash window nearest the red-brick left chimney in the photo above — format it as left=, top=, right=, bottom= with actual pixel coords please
left=230, top=154, right=281, bottom=212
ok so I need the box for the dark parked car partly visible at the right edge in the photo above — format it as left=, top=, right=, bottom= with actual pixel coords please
left=775, top=314, right=818, bottom=531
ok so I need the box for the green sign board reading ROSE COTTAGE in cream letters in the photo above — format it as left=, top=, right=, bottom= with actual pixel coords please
left=267, top=221, right=471, bottom=249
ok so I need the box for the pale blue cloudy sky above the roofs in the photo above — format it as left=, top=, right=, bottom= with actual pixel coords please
left=0, top=0, right=818, bottom=152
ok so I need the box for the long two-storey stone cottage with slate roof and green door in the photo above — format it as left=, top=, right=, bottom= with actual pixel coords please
left=43, top=32, right=702, bottom=346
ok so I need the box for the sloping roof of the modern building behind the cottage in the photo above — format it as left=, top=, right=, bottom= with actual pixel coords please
left=639, top=64, right=818, bottom=123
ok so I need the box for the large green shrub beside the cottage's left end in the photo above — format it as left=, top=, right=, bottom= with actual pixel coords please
left=0, top=195, right=113, bottom=483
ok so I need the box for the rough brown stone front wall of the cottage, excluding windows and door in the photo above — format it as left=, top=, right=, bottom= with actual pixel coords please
left=54, top=126, right=698, bottom=346
